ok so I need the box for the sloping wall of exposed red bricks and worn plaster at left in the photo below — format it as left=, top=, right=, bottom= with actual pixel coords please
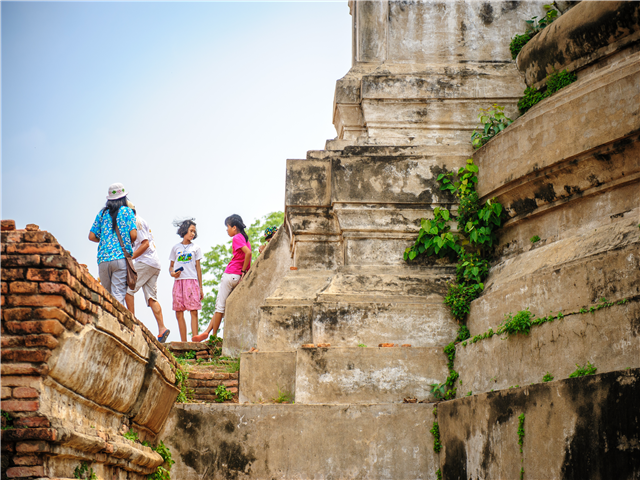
left=0, top=225, right=178, bottom=479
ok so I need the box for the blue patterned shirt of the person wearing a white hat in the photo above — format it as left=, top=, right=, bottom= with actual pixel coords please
left=91, top=207, right=136, bottom=263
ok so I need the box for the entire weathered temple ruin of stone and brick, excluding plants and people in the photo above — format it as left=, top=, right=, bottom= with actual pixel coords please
left=0, top=0, right=640, bottom=480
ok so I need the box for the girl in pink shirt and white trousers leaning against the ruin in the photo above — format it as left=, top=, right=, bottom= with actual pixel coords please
left=191, top=214, right=251, bottom=342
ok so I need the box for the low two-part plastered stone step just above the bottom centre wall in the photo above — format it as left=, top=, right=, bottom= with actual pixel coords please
left=240, top=347, right=448, bottom=404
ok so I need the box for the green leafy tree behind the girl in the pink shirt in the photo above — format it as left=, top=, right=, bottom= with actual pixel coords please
left=199, top=212, right=284, bottom=327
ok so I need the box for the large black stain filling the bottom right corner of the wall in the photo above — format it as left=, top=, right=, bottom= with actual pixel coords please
left=561, top=369, right=640, bottom=480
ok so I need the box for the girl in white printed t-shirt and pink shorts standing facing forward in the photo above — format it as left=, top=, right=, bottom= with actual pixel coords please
left=169, top=220, right=204, bottom=342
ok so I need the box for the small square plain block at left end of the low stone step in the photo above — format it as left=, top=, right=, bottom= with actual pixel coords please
left=240, top=352, right=296, bottom=403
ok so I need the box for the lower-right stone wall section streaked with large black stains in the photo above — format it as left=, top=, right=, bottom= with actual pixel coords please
left=438, top=369, right=640, bottom=479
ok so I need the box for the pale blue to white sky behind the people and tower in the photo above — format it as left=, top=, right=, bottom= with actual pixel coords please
left=0, top=0, right=351, bottom=340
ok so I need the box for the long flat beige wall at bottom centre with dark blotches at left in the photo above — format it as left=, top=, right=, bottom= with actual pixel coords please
left=160, top=404, right=439, bottom=480
